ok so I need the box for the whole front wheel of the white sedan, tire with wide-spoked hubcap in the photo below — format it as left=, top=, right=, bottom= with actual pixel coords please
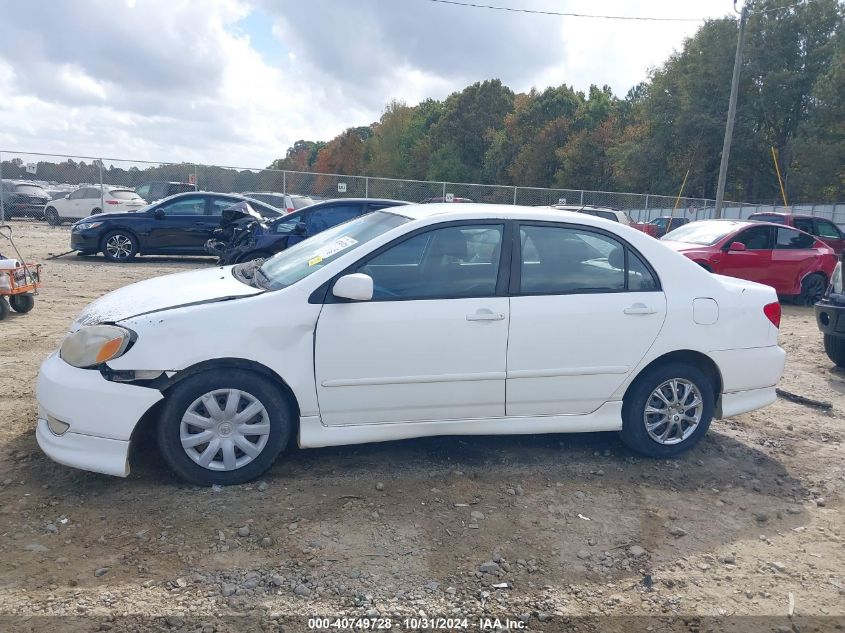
left=158, top=370, right=293, bottom=486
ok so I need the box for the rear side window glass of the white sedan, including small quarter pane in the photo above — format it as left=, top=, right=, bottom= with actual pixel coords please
left=519, top=226, right=659, bottom=294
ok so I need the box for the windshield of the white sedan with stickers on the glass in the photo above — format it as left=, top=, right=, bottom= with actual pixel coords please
left=260, top=211, right=410, bottom=290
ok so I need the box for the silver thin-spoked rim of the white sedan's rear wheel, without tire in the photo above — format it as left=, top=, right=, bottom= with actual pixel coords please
left=643, top=378, right=704, bottom=445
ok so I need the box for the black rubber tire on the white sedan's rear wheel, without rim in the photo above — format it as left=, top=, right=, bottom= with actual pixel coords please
left=620, top=362, right=715, bottom=457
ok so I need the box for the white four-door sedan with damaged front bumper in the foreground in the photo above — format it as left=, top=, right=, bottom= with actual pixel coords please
left=36, top=204, right=785, bottom=485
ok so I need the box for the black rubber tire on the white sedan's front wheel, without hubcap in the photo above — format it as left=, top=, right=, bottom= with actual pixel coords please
left=157, top=369, right=293, bottom=486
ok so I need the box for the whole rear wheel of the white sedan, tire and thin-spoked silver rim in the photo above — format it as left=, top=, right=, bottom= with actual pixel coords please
left=621, top=362, right=715, bottom=457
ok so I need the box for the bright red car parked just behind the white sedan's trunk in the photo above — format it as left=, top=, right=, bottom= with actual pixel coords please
left=661, top=220, right=837, bottom=305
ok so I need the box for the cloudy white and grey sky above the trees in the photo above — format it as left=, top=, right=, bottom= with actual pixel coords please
left=0, top=0, right=731, bottom=167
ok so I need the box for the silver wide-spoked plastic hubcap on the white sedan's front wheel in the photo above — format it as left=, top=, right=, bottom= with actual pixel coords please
left=179, top=389, right=270, bottom=471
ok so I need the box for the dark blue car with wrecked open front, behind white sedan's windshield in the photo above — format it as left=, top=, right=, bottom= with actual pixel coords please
left=211, top=198, right=410, bottom=264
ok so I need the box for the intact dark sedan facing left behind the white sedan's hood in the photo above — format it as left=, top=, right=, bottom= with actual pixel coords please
left=70, top=191, right=281, bottom=262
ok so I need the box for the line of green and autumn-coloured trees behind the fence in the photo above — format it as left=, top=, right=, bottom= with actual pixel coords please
left=270, top=0, right=845, bottom=204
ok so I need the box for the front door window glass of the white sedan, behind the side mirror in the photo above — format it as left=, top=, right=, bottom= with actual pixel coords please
left=357, top=224, right=504, bottom=300
